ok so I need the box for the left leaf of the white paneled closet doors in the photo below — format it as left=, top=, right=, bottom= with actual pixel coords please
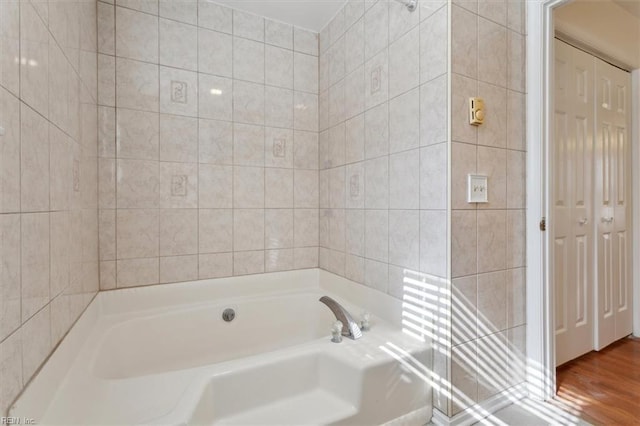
left=550, top=41, right=594, bottom=365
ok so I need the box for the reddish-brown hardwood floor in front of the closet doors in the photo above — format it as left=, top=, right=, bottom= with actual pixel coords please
left=555, top=338, right=640, bottom=425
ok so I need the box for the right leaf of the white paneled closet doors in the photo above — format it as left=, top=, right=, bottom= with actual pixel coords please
left=594, top=59, right=632, bottom=349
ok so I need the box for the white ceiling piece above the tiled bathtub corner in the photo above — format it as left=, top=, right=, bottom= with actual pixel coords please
left=215, top=0, right=346, bottom=33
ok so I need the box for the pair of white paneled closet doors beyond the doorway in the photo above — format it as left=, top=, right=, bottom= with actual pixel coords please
left=550, top=40, right=632, bottom=365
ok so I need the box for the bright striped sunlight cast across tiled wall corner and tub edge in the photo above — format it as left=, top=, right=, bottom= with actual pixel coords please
left=380, top=269, right=580, bottom=425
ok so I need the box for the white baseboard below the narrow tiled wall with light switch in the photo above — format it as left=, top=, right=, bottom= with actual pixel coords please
left=431, top=383, right=527, bottom=426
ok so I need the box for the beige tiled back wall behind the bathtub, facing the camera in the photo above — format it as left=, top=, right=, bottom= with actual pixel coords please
left=98, top=0, right=318, bottom=289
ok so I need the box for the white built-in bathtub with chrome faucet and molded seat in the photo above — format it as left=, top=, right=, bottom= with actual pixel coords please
left=11, top=270, right=431, bottom=425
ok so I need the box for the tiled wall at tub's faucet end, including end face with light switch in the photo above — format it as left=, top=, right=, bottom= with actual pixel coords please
left=319, top=0, right=525, bottom=416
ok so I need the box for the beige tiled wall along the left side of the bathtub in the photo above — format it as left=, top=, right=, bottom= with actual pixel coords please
left=0, top=0, right=98, bottom=416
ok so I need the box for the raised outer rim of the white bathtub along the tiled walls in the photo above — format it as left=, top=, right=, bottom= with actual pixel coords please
left=9, top=268, right=430, bottom=419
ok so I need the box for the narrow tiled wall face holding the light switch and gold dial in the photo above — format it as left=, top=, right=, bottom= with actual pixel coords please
left=451, top=0, right=526, bottom=414
